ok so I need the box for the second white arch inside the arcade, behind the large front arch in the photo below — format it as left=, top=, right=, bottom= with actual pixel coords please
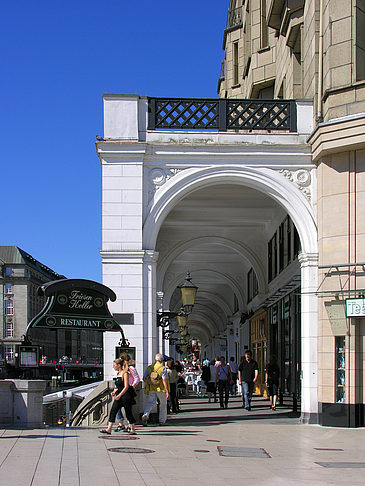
left=157, top=236, right=267, bottom=293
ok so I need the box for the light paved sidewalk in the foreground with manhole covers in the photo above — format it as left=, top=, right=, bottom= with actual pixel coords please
left=0, top=398, right=365, bottom=486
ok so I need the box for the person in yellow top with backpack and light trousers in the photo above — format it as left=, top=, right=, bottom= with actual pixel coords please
left=142, top=353, right=170, bottom=426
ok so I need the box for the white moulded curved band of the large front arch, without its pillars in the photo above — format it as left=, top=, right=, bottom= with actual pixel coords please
left=143, top=165, right=317, bottom=254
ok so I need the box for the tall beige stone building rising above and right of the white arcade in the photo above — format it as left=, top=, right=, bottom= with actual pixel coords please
left=218, top=0, right=365, bottom=426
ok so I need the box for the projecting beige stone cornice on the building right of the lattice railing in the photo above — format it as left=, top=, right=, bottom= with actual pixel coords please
left=308, top=113, right=365, bottom=162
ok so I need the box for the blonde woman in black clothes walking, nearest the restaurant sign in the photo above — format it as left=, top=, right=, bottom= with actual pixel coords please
left=100, top=358, right=136, bottom=435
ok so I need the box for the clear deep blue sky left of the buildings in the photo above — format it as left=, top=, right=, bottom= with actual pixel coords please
left=0, top=0, right=229, bottom=281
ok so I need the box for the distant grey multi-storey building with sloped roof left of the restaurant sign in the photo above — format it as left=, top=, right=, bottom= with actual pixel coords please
left=0, top=246, right=65, bottom=363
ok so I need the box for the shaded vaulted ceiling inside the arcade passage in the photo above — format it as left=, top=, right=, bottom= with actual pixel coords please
left=156, top=184, right=286, bottom=342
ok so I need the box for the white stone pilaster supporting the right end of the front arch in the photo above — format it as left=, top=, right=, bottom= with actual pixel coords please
left=298, top=253, right=318, bottom=423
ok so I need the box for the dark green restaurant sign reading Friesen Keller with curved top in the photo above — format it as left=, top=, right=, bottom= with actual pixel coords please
left=27, top=279, right=122, bottom=332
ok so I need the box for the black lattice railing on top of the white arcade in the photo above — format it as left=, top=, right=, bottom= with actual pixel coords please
left=148, top=98, right=297, bottom=132
